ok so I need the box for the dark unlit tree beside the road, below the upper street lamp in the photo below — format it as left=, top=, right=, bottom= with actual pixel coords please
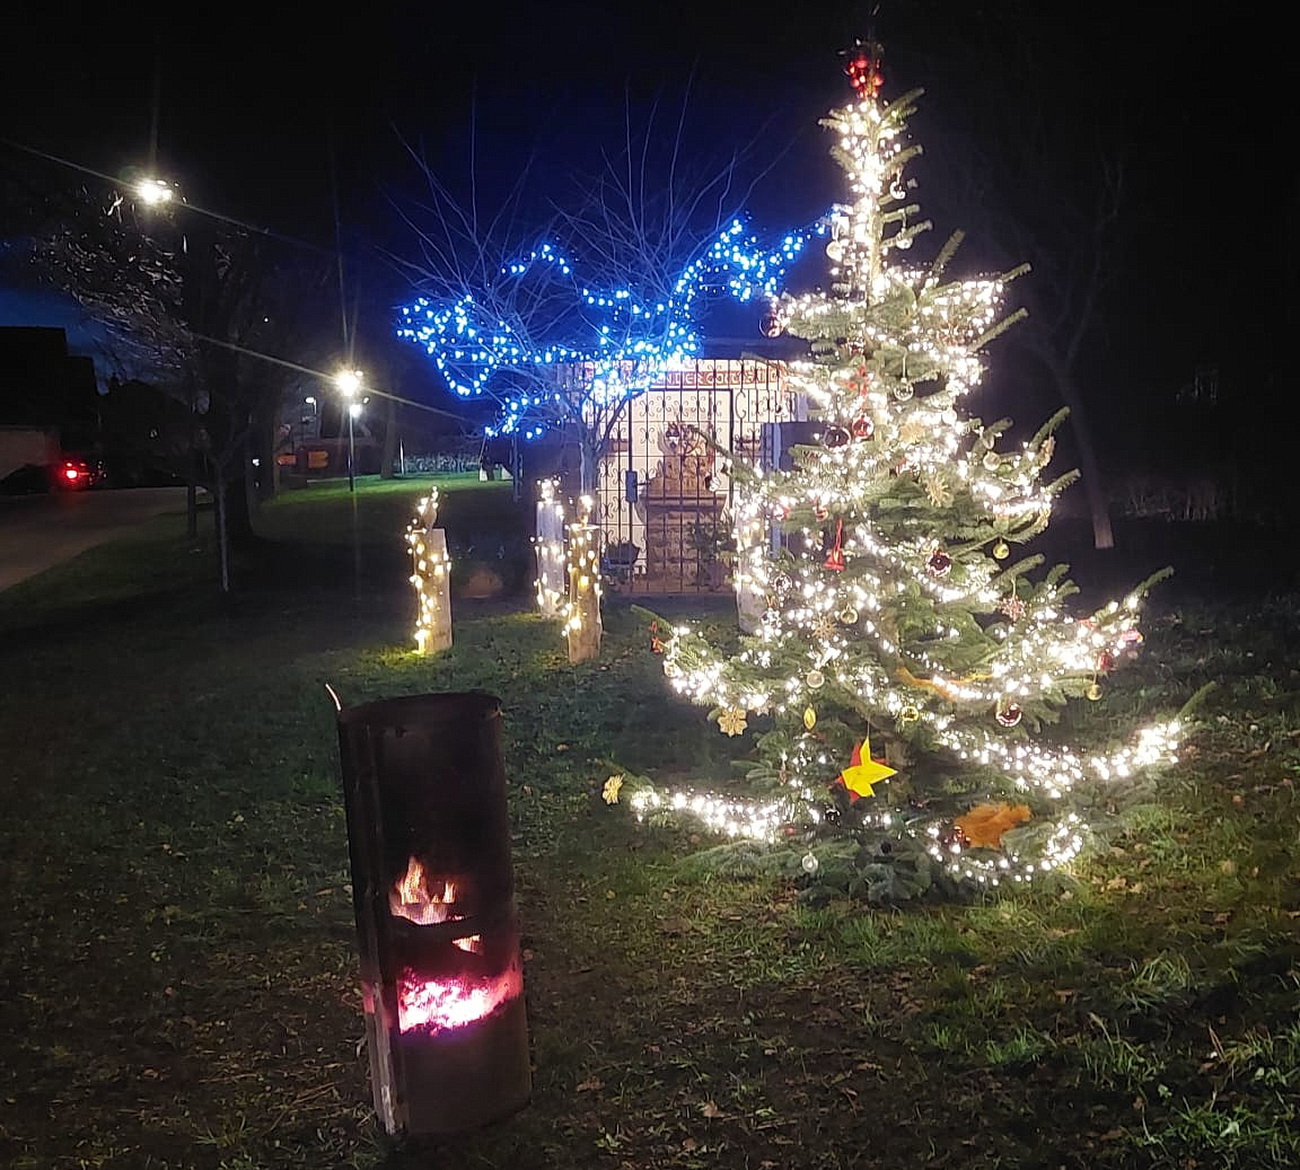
left=33, top=189, right=326, bottom=592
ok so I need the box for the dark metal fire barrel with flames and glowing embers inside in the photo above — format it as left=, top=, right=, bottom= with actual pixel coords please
left=338, top=693, right=532, bottom=1135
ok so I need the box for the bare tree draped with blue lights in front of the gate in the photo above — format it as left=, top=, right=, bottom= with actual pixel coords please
left=397, top=92, right=803, bottom=490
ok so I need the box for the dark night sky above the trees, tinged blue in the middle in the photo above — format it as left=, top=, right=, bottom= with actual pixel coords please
left=0, top=0, right=1300, bottom=447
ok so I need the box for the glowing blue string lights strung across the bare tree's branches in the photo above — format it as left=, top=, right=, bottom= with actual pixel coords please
left=397, top=218, right=826, bottom=439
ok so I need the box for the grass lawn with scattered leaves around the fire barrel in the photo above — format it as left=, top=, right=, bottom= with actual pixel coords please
left=0, top=481, right=1300, bottom=1170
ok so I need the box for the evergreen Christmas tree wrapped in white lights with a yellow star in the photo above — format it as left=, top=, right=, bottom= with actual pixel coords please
left=633, top=46, right=1178, bottom=898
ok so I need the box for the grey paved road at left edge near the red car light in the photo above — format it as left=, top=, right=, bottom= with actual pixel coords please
left=0, top=488, right=185, bottom=590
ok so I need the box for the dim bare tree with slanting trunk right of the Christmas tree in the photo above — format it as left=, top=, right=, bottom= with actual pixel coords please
left=904, top=9, right=1128, bottom=549
